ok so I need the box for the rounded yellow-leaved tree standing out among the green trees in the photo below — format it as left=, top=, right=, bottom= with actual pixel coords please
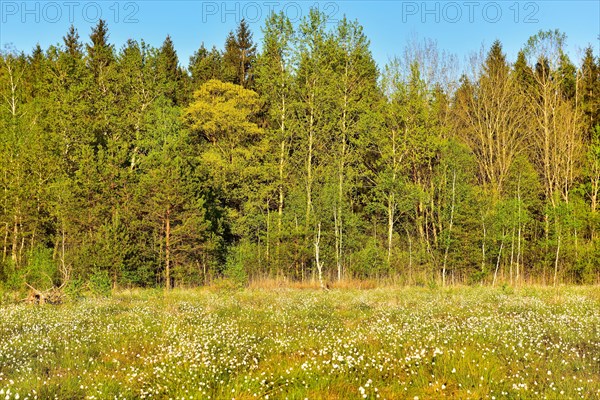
left=183, top=80, right=264, bottom=255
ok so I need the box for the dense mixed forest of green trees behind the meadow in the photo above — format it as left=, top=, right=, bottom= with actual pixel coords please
left=0, top=11, right=600, bottom=288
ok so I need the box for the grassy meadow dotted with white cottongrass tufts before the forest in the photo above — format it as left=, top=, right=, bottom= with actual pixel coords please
left=0, top=287, right=600, bottom=399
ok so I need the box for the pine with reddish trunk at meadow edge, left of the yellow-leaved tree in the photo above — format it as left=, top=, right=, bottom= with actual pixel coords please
left=135, top=97, right=209, bottom=289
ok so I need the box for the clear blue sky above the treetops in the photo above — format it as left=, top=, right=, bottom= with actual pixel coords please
left=0, top=0, right=600, bottom=66
